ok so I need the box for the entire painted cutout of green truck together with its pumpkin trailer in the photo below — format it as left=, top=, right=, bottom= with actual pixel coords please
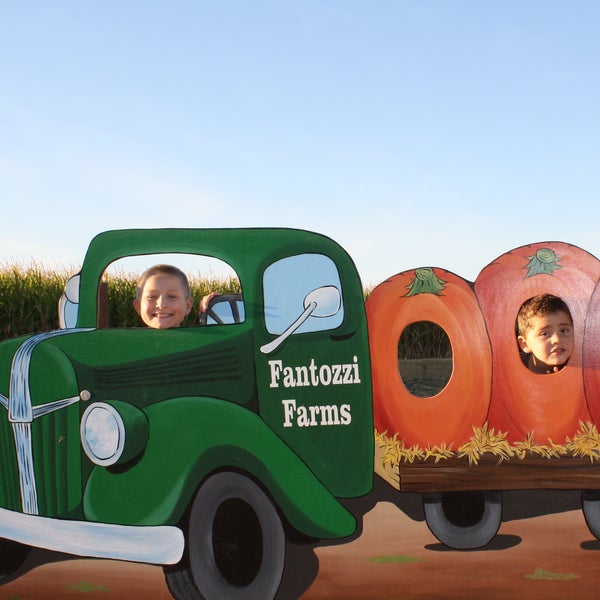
left=5, top=229, right=600, bottom=599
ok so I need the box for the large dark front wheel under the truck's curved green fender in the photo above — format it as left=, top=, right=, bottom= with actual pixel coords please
left=165, top=472, right=286, bottom=600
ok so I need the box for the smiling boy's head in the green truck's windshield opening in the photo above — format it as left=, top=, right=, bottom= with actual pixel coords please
left=133, top=274, right=193, bottom=329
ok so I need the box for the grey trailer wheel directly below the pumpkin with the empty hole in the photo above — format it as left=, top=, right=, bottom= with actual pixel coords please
left=423, top=491, right=502, bottom=550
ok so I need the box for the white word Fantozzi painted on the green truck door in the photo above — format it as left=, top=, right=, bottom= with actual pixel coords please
left=269, top=356, right=360, bottom=388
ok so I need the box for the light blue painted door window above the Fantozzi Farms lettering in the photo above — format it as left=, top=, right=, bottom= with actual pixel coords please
left=263, top=254, right=344, bottom=335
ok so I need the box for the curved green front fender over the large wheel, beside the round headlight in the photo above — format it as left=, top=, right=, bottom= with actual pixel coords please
left=84, top=397, right=356, bottom=539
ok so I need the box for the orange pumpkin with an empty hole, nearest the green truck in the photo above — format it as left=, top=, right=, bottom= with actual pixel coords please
left=366, top=268, right=491, bottom=449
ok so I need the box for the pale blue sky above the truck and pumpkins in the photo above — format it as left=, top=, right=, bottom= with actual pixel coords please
left=0, top=0, right=600, bottom=285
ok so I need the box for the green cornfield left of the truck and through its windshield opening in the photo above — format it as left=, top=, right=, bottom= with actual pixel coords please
left=0, top=264, right=240, bottom=340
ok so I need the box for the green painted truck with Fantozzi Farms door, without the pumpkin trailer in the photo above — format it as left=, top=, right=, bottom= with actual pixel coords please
left=0, top=228, right=373, bottom=598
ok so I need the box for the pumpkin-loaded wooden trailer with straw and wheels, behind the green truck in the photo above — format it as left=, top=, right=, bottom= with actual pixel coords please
left=367, top=242, right=600, bottom=548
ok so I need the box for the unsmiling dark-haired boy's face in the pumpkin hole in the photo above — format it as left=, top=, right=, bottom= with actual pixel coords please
left=518, top=311, right=574, bottom=373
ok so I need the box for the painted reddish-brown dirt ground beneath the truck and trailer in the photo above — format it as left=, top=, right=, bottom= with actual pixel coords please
left=0, top=484, right=600, bottom=600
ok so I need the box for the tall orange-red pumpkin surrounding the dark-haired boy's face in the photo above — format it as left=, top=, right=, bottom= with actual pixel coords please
left=475, top=242, right=600, bottom=444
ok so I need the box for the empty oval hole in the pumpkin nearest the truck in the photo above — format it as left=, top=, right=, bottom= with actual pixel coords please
left=398, top=321, right=452, bottom=398
